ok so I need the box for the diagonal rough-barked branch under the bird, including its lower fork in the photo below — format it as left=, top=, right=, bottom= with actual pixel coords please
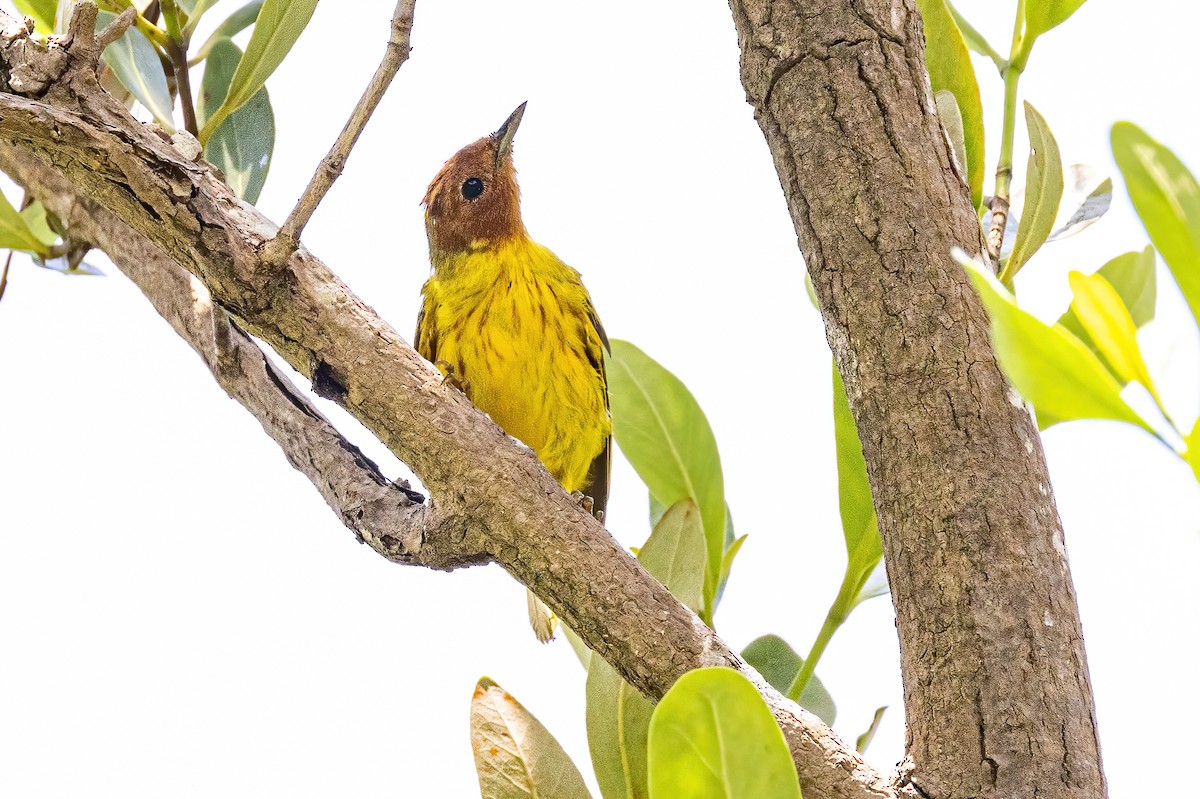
left=0, top=4, right=896, bottom=799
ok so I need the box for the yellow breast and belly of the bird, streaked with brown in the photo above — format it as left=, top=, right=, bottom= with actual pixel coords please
left=418, top=238, right=612, bottom=491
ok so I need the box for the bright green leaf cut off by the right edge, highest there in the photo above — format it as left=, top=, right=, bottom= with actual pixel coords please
left=1112, top=122, right=1200, bottom=325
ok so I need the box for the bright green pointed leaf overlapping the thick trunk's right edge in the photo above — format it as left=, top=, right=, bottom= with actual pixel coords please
left=954, top=248, right=1157, bottom=437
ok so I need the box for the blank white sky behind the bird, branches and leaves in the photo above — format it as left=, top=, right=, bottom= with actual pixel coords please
left=0, top=0, right=1200, bottom=797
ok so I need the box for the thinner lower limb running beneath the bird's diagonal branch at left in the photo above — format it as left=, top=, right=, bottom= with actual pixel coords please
left=0, top=127, right=482, bottom=569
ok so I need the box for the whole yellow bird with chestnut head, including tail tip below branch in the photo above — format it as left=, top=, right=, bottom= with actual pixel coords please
left=415, top=103, right=612, bottom=643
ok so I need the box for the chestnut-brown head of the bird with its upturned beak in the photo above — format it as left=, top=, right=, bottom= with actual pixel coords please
left=422, top=103, right=526, bottom=256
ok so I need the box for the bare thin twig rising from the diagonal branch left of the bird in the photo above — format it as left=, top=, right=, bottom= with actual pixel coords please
left=264, top=0, right=416, bottom=263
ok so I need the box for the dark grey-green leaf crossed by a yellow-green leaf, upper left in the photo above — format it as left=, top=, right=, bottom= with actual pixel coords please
left=196, top=38, right=275, bottom=205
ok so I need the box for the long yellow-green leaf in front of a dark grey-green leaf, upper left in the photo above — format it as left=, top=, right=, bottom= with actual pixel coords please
left=200, top=0, right=317, bottom=144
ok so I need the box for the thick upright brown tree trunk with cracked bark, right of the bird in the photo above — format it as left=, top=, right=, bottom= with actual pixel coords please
left=731, top=0, right=1105, bottom=799
